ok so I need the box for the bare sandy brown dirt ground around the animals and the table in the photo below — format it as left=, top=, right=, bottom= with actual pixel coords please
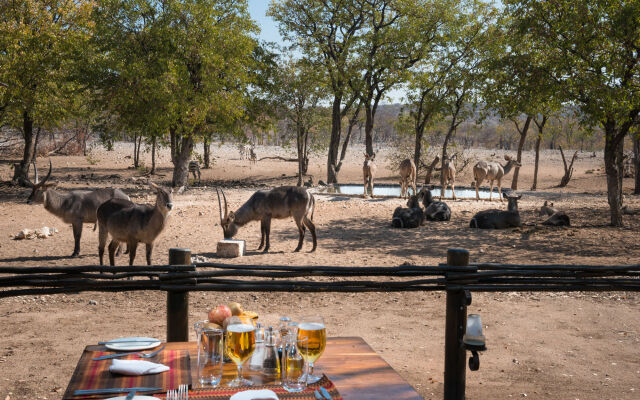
left=0, top=144, right=640, bottom=400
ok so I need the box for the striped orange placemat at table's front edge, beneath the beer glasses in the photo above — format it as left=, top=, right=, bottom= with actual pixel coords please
left=161, top=374, right=343, bottom=400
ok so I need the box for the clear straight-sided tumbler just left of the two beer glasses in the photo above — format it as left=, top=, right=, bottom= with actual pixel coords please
left=198, top=328, right=224, bottom=386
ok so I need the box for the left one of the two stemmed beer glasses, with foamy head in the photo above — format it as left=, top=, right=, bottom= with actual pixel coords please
left=225, top=317, right=256, bottom=387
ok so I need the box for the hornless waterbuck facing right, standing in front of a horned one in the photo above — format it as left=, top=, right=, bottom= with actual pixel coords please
left=97, top=182, right=173, bottom=265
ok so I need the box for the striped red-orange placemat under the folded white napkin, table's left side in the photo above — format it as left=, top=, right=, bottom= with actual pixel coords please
left=62, top=349, right=191, bottom=399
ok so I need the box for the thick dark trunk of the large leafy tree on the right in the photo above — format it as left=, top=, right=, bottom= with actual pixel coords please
left=604, top=122, right=624, bottom=226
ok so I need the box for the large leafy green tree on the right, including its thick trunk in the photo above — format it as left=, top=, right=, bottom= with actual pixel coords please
left=504, top=0, right=640, bottom=226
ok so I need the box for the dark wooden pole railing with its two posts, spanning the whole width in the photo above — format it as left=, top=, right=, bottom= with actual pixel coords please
left=0, top=249, right=640, bottom=400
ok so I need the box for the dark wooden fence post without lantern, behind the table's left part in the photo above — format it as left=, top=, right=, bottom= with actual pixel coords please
left=167, top=248, right=191, bottom=342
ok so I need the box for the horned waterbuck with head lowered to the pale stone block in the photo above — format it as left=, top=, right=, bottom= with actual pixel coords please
left=216, top=186, right=316, bottom=253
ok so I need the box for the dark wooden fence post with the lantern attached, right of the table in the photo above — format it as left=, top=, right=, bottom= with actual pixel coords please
left=444, top=249, right=470, bottom=400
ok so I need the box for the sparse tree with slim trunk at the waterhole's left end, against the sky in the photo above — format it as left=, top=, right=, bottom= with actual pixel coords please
left=268, top=0, right=366, bottom=183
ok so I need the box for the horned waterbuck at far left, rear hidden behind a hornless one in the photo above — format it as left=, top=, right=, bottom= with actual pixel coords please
left=27, top=160, right=129, bottom=257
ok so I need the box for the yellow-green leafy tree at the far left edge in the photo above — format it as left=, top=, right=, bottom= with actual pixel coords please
left=0, top=0, right=93, bottom=185
